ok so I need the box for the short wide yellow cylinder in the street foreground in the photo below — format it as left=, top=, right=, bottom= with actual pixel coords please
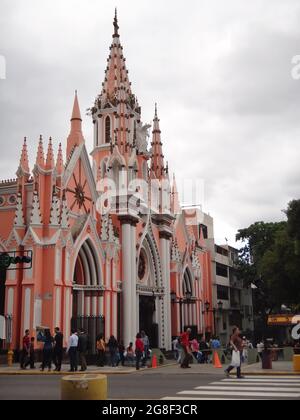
left=61, top=374, right=107, bottom=401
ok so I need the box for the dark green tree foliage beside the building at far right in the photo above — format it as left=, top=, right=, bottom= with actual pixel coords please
left=237, top=200, right=300, bottom=317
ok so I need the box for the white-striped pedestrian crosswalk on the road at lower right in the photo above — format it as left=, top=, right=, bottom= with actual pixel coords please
left=162, top=376, right=300, bottom=400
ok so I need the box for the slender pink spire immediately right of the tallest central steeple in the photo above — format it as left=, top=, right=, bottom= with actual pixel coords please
left=151, top=104, right=166, bottom=179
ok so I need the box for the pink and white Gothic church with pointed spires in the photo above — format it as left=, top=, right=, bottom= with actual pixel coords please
left=0, top=12, right=213, bottom=350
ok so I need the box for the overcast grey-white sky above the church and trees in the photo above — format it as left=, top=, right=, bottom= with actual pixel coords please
left=0, top=0, right=300, bottom=243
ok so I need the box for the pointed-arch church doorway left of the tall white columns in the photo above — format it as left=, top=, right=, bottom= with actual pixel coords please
left=71, top=239, right=105, bottom=354
